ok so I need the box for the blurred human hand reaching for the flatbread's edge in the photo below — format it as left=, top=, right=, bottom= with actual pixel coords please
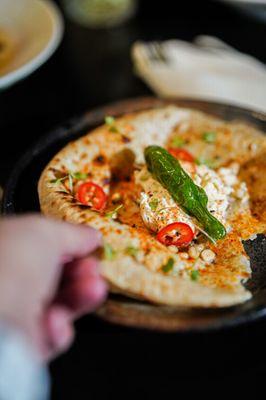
left=0, top=215, right=107, bottom=359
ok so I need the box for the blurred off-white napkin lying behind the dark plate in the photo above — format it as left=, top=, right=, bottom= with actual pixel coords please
left=132, top=36, right=266, bottom=112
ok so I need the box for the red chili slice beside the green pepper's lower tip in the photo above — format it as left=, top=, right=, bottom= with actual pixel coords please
left=156, top=222, right=194, bottom=247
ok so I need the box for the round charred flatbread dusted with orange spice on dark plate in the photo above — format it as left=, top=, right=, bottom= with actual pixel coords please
left=38, top=106, right=266, bottom=307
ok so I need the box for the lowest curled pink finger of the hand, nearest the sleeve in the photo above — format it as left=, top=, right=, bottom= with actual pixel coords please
left=43, top=305, right=74, bottom=360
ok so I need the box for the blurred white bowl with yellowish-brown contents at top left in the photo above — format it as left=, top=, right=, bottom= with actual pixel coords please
left=0, top=0, right=64, bottom=89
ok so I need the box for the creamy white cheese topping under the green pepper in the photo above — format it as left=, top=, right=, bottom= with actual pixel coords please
left=135, top=162, right=248, bottom=232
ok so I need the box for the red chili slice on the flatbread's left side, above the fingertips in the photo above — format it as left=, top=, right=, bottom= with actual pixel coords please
left=77, top=182, right=107, bottom=211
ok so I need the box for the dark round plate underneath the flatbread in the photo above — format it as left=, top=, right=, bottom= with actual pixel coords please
left=2, top=98, right=266, bottom=332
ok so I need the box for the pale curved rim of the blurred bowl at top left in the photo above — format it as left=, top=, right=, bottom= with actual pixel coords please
left=0, top=0, right=64, bottom=89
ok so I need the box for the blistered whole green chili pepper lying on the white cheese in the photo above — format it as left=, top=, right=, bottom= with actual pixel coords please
left=144, top=146, right=226, bottom=241
